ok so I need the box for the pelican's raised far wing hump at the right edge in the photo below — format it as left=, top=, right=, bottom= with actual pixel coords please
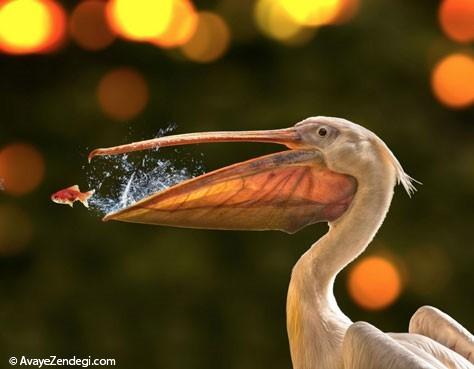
left=409, top=306, right=474, bottom=362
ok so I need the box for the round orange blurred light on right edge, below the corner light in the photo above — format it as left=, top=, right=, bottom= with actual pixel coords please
left=431, top=53, right=474, bottom=108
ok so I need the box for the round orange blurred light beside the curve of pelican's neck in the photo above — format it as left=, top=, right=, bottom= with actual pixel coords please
left=348, top=256, right=402, bottom=310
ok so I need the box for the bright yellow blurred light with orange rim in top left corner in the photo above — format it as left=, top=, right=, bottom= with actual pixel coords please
left=0, top=0, right=66, bottom=54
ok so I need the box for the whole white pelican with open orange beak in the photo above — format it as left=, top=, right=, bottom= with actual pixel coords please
left=89, top=116, right=474, bottom=369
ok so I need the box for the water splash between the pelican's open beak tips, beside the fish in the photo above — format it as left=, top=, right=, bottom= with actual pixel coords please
left=85, top=126, right=204, bottom=215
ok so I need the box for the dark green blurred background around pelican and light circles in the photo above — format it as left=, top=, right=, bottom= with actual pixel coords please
left=0, top=0, right=474, bottom=369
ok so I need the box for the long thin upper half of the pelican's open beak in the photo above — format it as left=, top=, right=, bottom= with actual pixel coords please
left=88, top=127, right=305, bottom=162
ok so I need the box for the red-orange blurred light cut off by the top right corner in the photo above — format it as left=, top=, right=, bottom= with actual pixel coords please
left=439, top=0, right=474, bottom=42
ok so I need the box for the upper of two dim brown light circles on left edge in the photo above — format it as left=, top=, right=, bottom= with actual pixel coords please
left=0, top=143, right=44, bottom=196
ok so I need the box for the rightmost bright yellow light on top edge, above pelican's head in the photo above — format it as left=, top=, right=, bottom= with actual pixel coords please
left=278, top=0, right=342, bottom=26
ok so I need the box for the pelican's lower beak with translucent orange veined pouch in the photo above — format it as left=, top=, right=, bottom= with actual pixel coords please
left=104, top=150, right=357, bottom=233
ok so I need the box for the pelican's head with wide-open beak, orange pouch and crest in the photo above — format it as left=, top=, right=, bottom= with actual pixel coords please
left=89, top=117, right=414, bottom=233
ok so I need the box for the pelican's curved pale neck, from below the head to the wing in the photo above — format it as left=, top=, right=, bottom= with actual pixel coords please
left=287, top=164, right=395, bottom=369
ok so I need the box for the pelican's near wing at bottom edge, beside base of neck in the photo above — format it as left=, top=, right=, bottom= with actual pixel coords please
left=342, top=322, right=440, bottom=369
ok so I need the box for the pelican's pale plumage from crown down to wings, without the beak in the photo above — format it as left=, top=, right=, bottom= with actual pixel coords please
left=287, top=117, right=474, bottom=369
